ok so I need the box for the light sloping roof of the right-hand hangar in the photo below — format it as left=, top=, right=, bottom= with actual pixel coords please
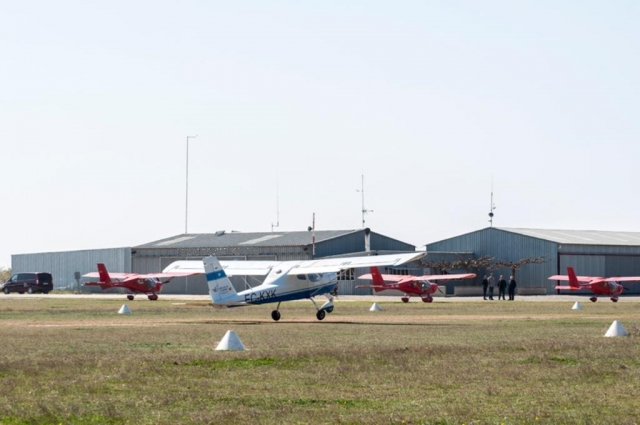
left=496, top=227, right=640, bottom=246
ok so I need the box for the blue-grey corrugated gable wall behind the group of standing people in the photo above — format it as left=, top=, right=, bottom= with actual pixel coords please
left=427, top=228, right=558, bottom=294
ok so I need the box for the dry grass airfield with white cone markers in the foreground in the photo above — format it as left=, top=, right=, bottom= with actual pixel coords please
left=0, top=296, right=640, bottom=424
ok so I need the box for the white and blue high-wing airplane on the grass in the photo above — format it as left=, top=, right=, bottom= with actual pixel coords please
left=163, top=252, right=425, bottom=321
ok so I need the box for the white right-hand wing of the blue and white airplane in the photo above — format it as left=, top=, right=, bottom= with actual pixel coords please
left=289, top=252, right=426, bottom=274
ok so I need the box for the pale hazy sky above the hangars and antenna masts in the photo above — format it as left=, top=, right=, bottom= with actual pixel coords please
left=0, top=0, right=640, bottom=266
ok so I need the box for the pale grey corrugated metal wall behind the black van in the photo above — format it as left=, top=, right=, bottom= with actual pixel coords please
left=11, top=248, right=131, bottom=292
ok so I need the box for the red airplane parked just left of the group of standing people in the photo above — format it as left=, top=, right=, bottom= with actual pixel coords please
left=356, top=267, right=476, bottom=303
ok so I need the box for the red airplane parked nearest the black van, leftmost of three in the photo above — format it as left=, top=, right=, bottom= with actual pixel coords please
left=82, top=263, right=199, bottom=301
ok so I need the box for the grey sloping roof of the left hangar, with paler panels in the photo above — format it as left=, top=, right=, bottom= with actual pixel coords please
left=134, top=229, right=362, bottom=248
